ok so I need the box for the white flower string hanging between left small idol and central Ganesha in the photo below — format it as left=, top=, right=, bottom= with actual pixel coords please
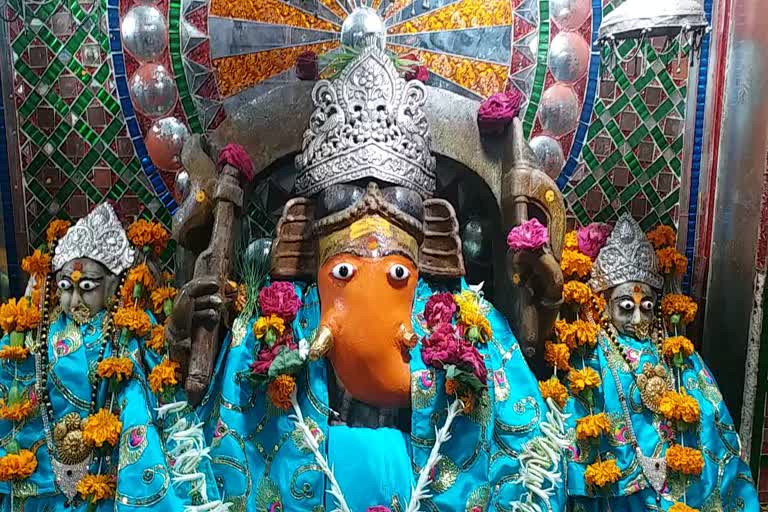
left=156, top=401, right=231, bottom=512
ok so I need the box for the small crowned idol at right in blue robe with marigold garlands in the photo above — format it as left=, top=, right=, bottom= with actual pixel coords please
left=566, top=214, right=759, bottom=512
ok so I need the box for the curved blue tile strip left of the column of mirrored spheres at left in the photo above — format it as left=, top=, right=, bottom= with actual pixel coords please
left=107, top=0, right=178, bottom=215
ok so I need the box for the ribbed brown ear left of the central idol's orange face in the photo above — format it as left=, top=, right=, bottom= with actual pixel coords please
left=272, top=197, right=316, bottom=280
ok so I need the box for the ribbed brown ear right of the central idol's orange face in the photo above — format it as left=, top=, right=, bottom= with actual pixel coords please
left=419, top=199, right=464, bottom=278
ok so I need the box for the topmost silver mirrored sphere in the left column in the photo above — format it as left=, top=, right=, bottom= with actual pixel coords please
left=120, top=5, right=168, bottom=62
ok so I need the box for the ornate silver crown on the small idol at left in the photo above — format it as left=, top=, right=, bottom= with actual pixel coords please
left=53, top=203, right=135, bottom=274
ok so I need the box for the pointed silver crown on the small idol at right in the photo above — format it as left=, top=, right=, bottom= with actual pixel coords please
left=589, top=213, right=664, bottom=292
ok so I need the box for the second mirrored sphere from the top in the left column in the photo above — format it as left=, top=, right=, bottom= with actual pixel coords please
left=128, top=64, right=177, bottom=117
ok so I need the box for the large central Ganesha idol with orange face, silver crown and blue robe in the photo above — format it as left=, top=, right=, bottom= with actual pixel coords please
left=168, top=8, right=566, bottom=512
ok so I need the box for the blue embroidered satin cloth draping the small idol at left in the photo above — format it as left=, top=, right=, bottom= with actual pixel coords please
left=0, top=311, right=218, bottom=512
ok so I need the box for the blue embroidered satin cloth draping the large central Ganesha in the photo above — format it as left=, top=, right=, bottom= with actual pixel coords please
left=199, top=280, right=565, bottom=512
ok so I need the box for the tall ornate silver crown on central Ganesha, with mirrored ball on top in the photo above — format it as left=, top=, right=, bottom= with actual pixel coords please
left=296, top=7, right=435, bottom=197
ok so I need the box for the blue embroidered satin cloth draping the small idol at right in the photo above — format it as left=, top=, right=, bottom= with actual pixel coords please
left=566, top=332, right=759, bottom=512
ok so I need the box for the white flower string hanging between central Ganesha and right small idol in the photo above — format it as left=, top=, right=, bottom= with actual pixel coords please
left=511, top=398, right=569, bottom=512
